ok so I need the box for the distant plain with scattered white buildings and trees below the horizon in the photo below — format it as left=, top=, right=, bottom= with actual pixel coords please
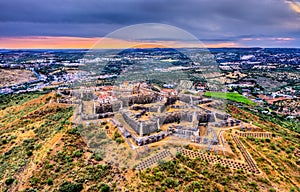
left=0, top=48, right=300, bottom=120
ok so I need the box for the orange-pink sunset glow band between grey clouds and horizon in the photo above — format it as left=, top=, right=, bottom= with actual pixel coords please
left=0, top=36, right=239, bottom=49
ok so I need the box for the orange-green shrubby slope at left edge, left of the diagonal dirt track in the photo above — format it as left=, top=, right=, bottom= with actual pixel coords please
left=0, top=93, right=72, bottom=189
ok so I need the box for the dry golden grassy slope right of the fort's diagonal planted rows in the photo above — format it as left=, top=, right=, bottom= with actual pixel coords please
left=229, top=106, right=300, bottom=188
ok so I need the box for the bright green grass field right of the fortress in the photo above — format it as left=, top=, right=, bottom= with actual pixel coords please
left=204, top=92, right=255, bottom=105
